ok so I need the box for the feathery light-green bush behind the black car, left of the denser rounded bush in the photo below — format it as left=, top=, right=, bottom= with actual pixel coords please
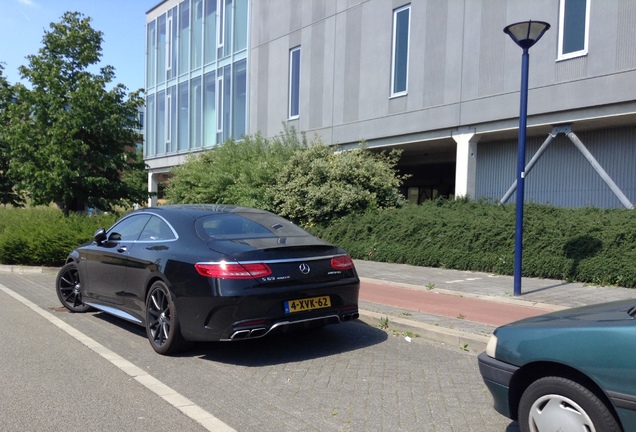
left=166, top=129, right=307, bottom=210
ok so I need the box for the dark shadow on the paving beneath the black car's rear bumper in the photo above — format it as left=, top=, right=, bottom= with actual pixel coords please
left=191, top=320, right=388, bottom=367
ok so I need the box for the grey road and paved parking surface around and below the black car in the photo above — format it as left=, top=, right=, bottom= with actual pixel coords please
left=0, top=273, right=517, bottom=432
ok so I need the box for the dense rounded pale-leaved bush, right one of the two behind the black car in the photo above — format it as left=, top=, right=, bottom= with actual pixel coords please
left=272, top=145, right=405, bottom=226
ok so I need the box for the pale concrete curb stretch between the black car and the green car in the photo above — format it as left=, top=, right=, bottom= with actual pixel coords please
left=358, top=309, right=490, bottom=353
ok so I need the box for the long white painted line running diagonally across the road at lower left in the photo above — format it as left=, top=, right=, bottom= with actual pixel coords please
left=0, top=284, right=236, bottom=432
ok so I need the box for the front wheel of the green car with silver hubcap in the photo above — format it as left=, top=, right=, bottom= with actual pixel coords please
left=519, top=376, right=621, bottom=432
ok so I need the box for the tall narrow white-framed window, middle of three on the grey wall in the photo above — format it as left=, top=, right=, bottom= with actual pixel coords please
left=391, top=5, right=411, bottom=96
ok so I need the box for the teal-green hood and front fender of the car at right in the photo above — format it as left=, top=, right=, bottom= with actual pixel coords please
left=495, top=299, right=636, bottom=394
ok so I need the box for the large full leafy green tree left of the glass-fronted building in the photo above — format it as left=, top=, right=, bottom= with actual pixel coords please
left=9, top=12, right=147, bottom=213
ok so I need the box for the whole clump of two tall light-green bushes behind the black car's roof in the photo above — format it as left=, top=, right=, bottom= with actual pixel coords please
left=166, top=129, right=403, bottom=226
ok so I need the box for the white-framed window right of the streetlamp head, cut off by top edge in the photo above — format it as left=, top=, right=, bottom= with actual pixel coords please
left=559, top=0, right=590, bottom=60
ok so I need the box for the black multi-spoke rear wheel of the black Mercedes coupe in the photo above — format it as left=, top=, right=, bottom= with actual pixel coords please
left=146, top=281, right=188, bottom=355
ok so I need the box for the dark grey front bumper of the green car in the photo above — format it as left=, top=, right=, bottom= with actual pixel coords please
left=477, top=352, right=519, bottom=418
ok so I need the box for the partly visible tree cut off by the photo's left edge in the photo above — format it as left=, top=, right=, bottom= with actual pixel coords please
left=0, top=63, right=24, bottom=207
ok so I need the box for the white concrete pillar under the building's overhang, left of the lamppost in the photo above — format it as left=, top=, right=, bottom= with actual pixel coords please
left=453, top=131, right=479, bottom=199
